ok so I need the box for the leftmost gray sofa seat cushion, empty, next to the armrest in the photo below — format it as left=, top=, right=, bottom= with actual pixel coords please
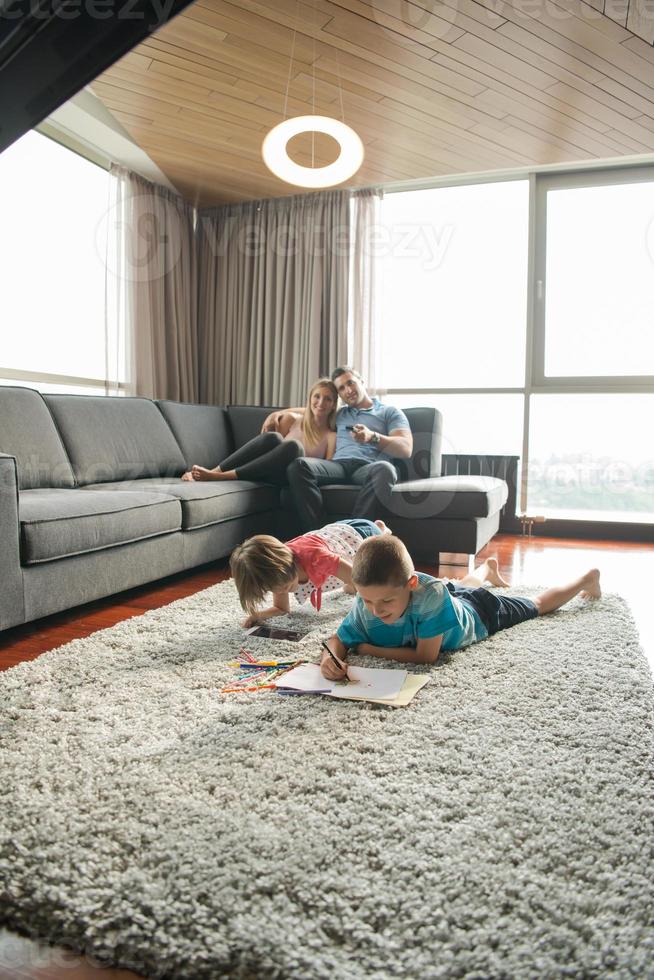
left=19, top=489, right=182, bottom=565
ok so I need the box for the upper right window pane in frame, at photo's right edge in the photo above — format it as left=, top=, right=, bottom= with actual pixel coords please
left=536, top=174, right=654, bottom=381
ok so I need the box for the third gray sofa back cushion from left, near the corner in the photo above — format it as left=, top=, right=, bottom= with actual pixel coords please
left=156, top=401, right=232, bottom=469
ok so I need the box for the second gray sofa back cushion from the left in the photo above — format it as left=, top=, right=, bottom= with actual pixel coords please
left=44, top=395, right=185, bottom=486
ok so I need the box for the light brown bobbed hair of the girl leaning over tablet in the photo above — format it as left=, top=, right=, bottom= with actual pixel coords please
left=229, top=534, right=297, bottom=616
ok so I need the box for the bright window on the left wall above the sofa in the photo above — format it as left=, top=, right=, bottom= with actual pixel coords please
left=0, top=132, right=125, bottom=392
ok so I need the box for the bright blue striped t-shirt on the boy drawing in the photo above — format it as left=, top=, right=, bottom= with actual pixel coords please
left=336, top=572, right=488, bottom=650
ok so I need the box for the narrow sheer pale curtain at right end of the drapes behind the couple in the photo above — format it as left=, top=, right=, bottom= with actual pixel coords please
left=347, top=188, right=384, bottom=394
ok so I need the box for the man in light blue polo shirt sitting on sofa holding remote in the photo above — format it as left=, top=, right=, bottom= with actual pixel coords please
left=286, top=367, right=413, bottom=531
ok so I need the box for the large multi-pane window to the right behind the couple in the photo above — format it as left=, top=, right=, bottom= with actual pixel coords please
left=375, top=169, right=654, bottom=524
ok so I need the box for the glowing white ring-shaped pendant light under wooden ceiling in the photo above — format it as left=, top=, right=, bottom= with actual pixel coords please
left=261, top=116, right=364, bottom=187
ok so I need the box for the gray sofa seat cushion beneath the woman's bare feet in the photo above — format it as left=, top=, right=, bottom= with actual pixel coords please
left=83, top=478, right=279, bottom=531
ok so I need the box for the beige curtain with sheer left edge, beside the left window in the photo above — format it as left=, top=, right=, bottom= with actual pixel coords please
left=107, top=166, right=199, bottom=401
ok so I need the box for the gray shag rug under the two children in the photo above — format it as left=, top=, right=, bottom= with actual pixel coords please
left=0, top=582, right=654, bottom=980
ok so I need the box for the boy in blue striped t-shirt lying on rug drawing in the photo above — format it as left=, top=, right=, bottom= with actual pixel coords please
left=320, top=535, right=602, bottom=680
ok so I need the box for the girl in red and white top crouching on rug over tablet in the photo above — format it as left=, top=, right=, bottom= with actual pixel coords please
left=229, top=517, right=508, bottom=627
